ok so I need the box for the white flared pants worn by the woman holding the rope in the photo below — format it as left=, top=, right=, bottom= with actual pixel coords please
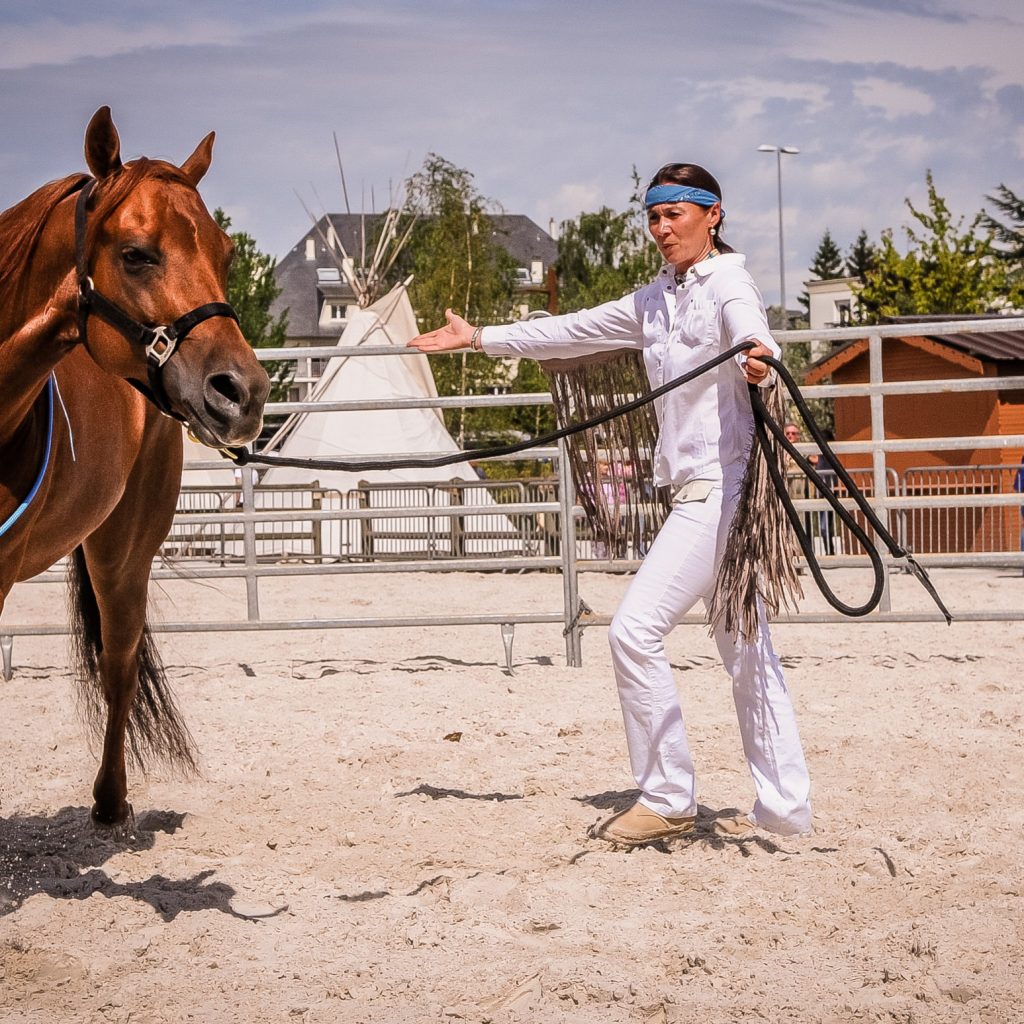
left=608, top=485, right=811, bottom=835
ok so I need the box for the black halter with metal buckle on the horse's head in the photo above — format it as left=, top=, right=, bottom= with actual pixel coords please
left=75, top=178, right=239, bottom=423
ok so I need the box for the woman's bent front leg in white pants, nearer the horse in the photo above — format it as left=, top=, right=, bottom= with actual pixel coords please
left=608, top=488, right=722, bottom=818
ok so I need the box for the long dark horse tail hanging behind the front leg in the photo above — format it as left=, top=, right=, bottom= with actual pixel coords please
left=68, top=547, right=199, bottom=774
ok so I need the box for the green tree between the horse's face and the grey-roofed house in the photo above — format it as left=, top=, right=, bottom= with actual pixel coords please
left=213, top=207, right=295, bottom=401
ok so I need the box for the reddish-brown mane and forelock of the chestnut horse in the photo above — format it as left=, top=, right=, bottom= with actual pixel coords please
left=0, top=157, right=195, bottom=312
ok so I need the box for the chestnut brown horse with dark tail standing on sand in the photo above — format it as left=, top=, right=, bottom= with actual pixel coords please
left=0, top=106, right=269, bottom=824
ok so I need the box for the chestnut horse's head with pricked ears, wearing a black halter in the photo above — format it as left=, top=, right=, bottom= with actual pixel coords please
left=80, top=106, right=270, bottom=446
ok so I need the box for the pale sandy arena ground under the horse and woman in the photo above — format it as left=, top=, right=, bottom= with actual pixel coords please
left=0, top=568, right=1024, bottom=1024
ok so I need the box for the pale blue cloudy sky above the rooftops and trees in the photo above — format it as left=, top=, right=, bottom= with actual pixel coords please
left=0, top=0, right=1024, bottom=306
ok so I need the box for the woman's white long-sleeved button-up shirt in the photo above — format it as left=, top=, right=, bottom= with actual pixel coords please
left=480, top=253, right=780, bottom=489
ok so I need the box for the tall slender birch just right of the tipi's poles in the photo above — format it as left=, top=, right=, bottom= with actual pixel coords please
left=391, top=154, right=515, bottom=444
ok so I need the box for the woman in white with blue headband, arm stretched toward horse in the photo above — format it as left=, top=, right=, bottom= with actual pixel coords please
left=410, top=164, right=811, bottom=846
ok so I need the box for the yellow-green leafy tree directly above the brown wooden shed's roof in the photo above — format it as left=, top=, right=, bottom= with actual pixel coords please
left=858, top=171, right=1007, bottom=323
